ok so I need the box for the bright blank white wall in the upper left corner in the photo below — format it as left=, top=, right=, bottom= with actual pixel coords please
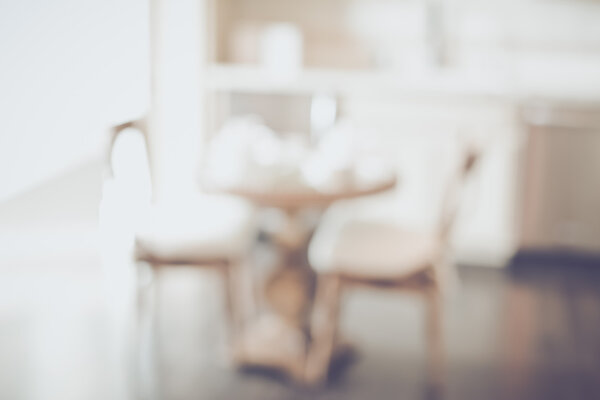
left=0, top=0, right=149, bottom=201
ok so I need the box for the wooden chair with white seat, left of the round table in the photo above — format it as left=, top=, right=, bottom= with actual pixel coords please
left=106, top=119, right=257, bottom=341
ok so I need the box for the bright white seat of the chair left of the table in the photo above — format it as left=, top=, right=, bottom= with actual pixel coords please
left=136, top=195, right=255, bottom=263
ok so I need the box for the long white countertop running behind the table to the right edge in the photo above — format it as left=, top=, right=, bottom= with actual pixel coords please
left=207, top=57, right=600, bottom=102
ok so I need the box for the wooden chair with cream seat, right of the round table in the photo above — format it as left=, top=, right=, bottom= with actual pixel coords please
left=305, top=147, right=478, bottom=388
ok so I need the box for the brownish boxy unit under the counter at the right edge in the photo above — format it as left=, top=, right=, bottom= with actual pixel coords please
left=519, top=101, right=600, bottom=254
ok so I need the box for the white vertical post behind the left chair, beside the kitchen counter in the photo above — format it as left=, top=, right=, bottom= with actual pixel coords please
left=150, top=0, right=206, bottom=201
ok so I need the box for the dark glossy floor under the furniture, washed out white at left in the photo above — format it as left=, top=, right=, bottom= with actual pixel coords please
left=0, top=164, right=600, bottom=400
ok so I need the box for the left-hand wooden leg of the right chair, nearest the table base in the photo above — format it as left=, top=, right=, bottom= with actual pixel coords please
left=304, top=276, right=342, bottom=385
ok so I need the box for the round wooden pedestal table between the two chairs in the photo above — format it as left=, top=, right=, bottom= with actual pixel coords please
left=212, top=173, right=396, bottom=382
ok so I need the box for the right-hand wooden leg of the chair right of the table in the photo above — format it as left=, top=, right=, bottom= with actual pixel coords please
left=425, top=289, right=444, bottom=389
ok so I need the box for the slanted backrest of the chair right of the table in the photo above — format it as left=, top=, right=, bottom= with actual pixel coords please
left=438, top=148, right=480, bottom=243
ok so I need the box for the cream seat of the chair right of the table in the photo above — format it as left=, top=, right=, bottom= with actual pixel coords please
left=309, top=217, right=439, bottom=280
